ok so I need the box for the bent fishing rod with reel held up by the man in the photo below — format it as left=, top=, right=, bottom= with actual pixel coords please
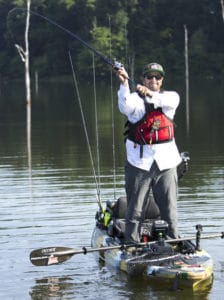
left=7, top=7, right=136, bottom=86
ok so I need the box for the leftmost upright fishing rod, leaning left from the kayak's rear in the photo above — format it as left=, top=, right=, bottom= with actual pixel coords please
left=69, top=51, right=102, bottom=210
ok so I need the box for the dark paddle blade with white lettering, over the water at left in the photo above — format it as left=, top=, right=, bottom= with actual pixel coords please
left=30, top=247, right=74, bottom=266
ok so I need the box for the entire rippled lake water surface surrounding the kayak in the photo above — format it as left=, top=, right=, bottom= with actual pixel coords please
left=0, top=81, right=224, bottom=300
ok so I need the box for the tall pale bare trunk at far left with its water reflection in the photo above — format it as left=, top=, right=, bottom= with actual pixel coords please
left=15, top=0, right=31, bottom=170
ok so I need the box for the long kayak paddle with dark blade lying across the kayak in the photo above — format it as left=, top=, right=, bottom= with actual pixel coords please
left=30, top=232, right=224, bottom=266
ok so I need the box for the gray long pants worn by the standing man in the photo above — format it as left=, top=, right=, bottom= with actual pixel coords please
left=125, top=161, right=178, bottom=243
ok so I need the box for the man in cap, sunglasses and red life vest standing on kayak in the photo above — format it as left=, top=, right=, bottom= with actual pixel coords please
left=116, top=63, right=181, bottom=243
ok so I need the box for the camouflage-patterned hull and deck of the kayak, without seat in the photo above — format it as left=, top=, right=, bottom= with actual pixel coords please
left=92, top=226, right=213, bottom=289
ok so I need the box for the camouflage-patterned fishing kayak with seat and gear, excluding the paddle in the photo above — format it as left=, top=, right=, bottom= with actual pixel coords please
left=91, top=197, right=213, bottom=290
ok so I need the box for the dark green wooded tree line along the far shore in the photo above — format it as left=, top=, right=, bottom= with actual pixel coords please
left=0, top=0, right=224, bottom=80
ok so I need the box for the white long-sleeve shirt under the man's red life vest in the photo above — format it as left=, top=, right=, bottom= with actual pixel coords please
left=118, top=84, right=181, bottom=171
